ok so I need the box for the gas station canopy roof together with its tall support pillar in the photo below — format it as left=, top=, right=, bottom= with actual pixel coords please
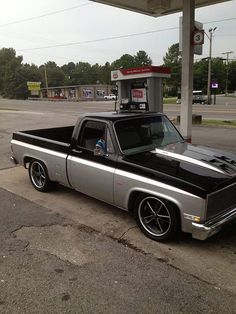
left=92, top=0, right=230, bottom=142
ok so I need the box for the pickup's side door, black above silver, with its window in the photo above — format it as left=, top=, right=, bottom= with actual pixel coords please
left=68, top=120, right=116, bottom=204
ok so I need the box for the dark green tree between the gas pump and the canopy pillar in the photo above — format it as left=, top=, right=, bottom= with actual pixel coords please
left=163, top=43, right=182, bottom=95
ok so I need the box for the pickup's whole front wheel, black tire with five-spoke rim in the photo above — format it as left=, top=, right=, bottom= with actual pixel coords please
left=134, top=195, right=180, bottom=242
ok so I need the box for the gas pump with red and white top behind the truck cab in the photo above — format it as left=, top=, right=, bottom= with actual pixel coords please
left=111, top=66, right=170, bottom=112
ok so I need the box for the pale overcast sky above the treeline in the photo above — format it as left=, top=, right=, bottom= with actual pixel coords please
left=0, top=0, right=236, bottom=65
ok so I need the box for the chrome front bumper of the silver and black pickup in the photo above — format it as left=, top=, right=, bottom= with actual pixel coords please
left=192, top=207, right=236, bottom=240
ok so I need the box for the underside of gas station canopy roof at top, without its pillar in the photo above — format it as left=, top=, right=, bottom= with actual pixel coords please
left=92, top=0, right=229, bottom=17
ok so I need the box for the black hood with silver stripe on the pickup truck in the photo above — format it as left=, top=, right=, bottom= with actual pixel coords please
left=125, top=143, right=236, bottom=194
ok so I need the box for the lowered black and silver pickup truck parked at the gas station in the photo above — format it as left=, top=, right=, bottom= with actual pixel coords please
left=11, top=112, right=236, bottom=241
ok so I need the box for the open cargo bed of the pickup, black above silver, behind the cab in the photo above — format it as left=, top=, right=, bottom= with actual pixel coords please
left=11, top=126, right=74, bottom=186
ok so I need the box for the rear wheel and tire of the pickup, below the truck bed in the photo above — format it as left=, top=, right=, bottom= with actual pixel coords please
left=29, top=160, right=55, bottom=192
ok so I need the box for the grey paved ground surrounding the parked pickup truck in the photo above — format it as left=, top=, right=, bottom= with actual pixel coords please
left=0, top=100, right=236, bottom=313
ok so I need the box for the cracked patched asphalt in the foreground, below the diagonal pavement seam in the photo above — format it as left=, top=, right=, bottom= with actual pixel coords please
left=0, top=188, right=236, bottom=313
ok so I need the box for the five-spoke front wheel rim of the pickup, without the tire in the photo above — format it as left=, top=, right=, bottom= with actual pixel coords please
left=138, top=196, right=172, bottom=237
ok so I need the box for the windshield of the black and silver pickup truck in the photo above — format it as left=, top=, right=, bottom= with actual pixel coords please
left=115, top=116, right=184, bottom=155
